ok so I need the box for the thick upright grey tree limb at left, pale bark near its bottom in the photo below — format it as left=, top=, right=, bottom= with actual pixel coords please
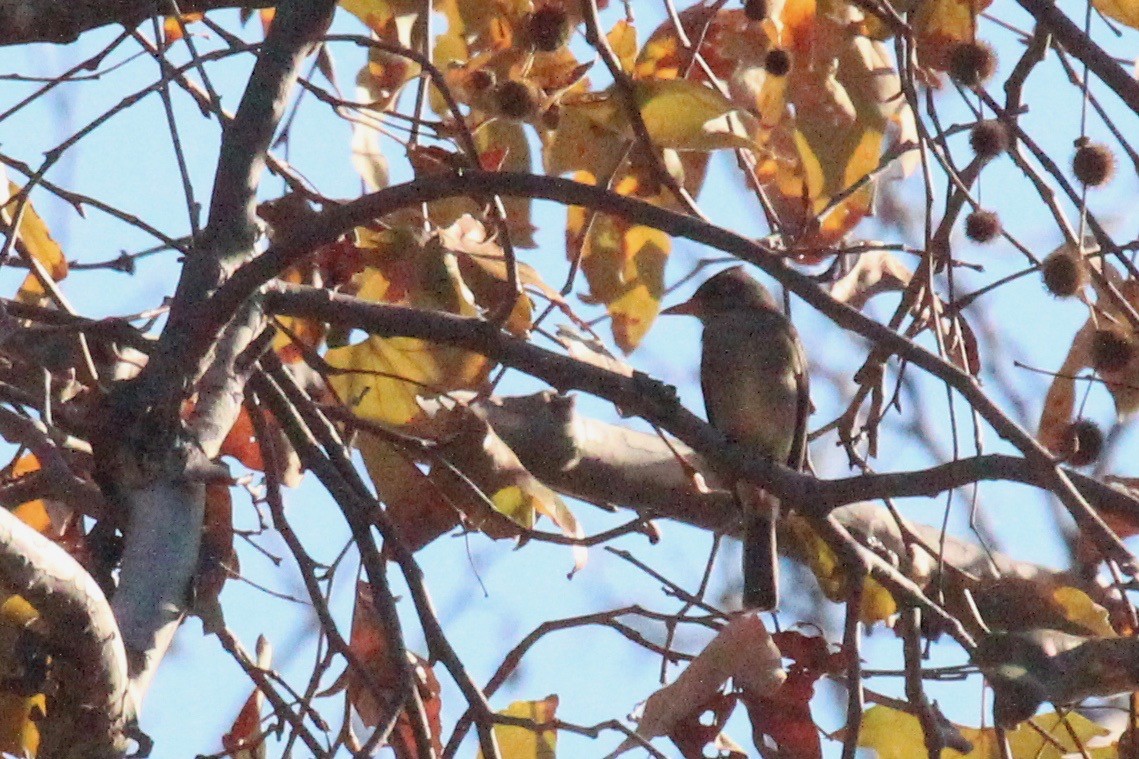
left=92, top=0, right=335, bottom=729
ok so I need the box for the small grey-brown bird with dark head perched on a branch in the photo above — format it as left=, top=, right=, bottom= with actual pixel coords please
left=662, top=266, right=811, bottom=611
